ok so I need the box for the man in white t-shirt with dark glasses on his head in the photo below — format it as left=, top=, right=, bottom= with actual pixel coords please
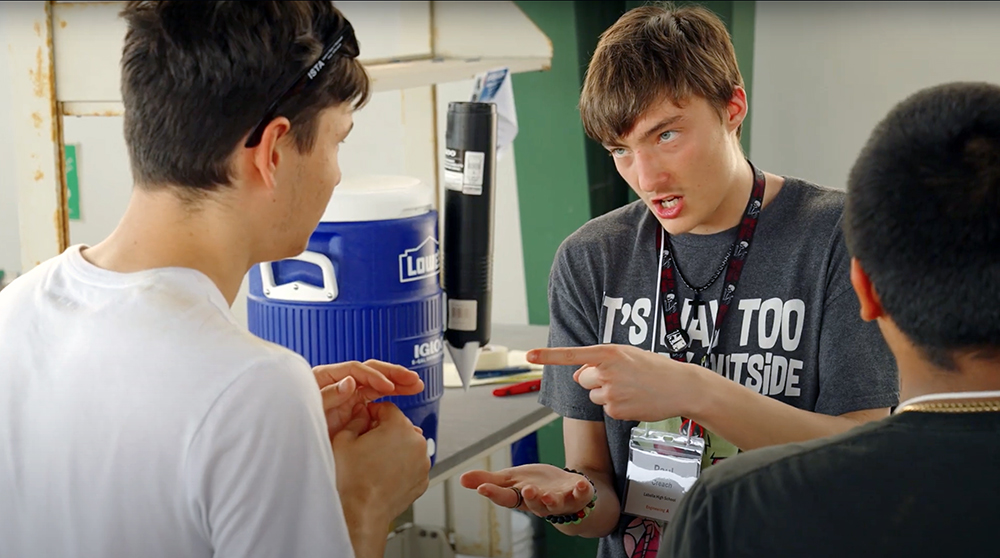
left=0, top=1, right=430, bottom=558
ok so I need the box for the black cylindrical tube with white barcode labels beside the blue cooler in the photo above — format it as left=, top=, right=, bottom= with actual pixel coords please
left=442, top=103, right=497, bottom=356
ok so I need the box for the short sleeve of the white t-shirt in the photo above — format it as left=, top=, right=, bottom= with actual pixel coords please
left=185, top=356, right=354, bottom=558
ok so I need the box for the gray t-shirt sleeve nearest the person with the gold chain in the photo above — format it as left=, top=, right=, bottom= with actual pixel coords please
left=816, top=223, right=899, bottom=415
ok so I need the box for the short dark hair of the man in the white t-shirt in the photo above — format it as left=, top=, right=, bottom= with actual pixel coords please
left=121, top=0, right=370, bottom=194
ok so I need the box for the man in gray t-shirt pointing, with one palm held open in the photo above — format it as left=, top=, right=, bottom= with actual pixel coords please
left=462, top=6, right=898, bottom=558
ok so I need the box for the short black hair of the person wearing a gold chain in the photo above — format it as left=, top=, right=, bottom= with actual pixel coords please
left=844, top=83, right=1000, bottom=369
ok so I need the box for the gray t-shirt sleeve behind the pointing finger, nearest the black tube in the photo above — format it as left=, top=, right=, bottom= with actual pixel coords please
left=538, top=237, right=604, bottom=421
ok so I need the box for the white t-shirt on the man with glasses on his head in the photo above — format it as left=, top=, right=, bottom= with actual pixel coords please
left=0, top=246, right=353, bottom=558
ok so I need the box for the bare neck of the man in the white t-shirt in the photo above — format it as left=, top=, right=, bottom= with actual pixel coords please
left=84, top=187, right=253, bottom=305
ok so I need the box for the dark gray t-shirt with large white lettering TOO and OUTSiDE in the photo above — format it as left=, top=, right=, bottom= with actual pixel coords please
left=539, top=178, right=899, bottom=558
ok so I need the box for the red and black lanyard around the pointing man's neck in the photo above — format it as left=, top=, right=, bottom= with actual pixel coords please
left=653, top=161, right=765, bottom=432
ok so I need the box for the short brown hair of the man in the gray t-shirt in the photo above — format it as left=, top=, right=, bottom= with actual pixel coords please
left=580, top=4, right=743, bottom=143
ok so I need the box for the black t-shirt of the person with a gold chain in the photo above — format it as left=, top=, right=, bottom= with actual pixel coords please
left=659, top=412, right=1000, bottom=558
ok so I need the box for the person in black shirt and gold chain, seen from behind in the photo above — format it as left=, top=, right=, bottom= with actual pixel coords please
left=659, top=83, right=1000, bottom=558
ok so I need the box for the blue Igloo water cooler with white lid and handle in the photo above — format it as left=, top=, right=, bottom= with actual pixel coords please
left=247, top=176, right=444, bottom=462
